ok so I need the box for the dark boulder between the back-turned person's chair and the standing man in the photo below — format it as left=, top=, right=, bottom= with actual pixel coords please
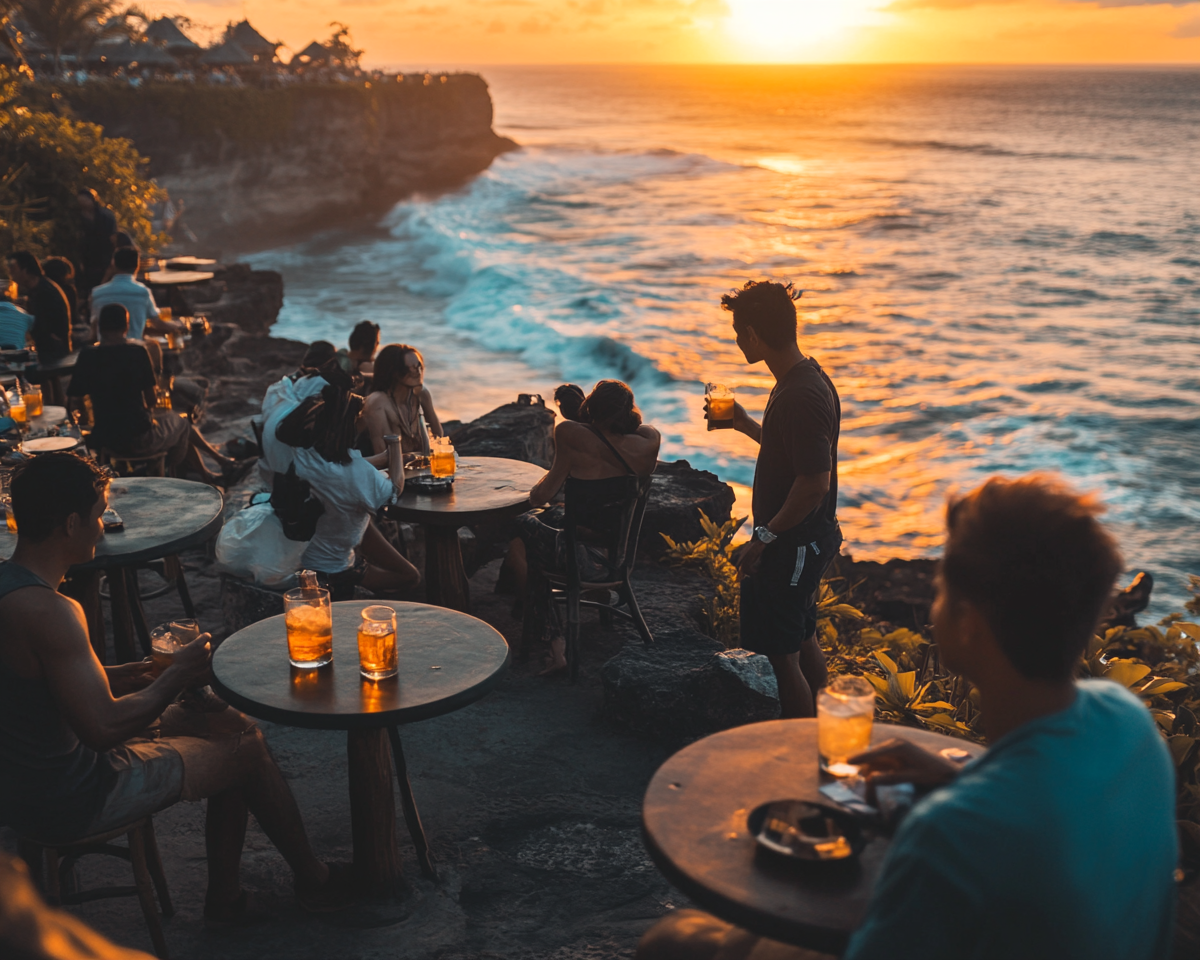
left=638, top=460, right=733, bottom=557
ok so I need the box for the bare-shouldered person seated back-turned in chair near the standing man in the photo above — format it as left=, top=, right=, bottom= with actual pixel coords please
left=510, top=380, right=662, bottom=674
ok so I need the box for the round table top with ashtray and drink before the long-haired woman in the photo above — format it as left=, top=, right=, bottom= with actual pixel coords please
left=390, top=457, right=546, bottom=527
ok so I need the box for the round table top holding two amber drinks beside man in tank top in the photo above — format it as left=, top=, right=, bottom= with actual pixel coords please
left=212, top=600, right=509, bottom=730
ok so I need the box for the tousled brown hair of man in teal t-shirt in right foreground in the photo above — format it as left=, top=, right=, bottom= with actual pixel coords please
left=942, top=474, right=1123, bottom=680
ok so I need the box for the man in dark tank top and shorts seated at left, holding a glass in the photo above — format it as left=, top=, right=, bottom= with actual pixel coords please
left=0, top=454, right=349, bottom=923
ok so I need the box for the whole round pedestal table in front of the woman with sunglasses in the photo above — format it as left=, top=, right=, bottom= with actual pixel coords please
left=388, top=457, right=546, bottom=610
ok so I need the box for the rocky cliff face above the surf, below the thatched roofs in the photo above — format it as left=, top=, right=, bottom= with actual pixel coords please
left=47, top=73, right=516, bottom=254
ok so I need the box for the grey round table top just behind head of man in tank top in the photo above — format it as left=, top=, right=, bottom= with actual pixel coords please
left=0, top=476, right=224, bottom=570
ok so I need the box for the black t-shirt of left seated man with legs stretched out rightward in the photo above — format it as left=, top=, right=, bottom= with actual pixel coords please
left=67, top=341, right=156, bottom=448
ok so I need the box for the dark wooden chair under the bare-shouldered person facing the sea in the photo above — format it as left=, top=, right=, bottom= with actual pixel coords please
left=526, top=476, right=654, bottom=680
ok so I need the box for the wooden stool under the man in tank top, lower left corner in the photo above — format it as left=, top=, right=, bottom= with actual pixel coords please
left=18, top=817, right=175, bottom=960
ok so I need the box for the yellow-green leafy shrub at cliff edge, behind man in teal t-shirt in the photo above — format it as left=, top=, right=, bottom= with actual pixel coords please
left=662, top=512, right=1200, bottom=866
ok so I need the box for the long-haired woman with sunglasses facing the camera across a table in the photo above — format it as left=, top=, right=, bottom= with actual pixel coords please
left=362, top=343, right=444, bottom=455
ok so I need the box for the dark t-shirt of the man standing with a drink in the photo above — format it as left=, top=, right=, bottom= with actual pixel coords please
left=754, top=356, right=841, bottom=544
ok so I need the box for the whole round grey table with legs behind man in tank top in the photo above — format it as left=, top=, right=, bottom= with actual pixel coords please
left=0, top=476, right=224, bottom=662
